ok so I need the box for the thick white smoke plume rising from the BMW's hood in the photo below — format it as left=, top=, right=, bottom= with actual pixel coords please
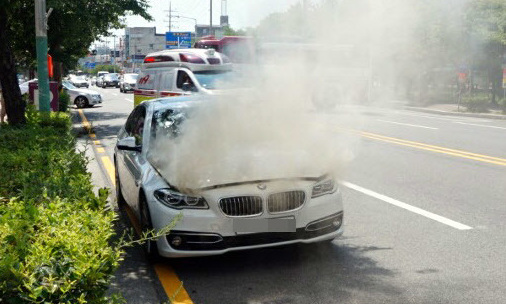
left=147, top=0, right=462, bottom=189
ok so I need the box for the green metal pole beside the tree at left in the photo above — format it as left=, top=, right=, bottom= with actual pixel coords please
left=35, top=0, right=50, bottom=112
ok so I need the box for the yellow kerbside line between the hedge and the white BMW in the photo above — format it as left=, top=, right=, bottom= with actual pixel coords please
left=78, top=109, right=193, bottom=304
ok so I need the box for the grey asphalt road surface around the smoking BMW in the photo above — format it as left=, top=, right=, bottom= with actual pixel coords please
left=74, top=87, right=506, bottom=304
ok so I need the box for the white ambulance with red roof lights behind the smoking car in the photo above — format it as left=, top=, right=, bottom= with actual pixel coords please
left=134, top=49, right=232, bottom=106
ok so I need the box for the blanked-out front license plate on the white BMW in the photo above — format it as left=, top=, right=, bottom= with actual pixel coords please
left=233, top=217, right=296, bottom=233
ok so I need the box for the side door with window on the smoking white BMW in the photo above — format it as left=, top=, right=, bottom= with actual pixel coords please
left=120, top=105, right=146, bottom=207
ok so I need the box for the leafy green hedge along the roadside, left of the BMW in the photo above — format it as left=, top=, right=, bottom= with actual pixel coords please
left=0, top=112, right=122, bottom=303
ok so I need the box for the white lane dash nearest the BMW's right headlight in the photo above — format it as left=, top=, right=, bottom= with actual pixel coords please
left=342, top=182, right=473, bottom=230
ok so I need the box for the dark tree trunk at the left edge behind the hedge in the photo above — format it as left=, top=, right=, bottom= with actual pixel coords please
left=0, top=5, right=26, bottom=125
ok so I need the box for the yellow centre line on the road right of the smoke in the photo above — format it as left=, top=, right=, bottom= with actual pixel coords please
left=354, top=131, right=506, bottom=166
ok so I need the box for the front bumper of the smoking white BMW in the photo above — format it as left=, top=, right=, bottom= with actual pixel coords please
left=148, top=184, right=343, bottom=258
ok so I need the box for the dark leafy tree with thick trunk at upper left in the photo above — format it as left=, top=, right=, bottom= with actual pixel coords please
left=0, top=0, right=151, bottom=124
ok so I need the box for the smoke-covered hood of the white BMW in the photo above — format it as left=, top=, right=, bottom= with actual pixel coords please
left=148, top=151, right=329, bottom=191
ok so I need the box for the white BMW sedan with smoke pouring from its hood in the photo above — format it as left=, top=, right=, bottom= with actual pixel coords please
left=114, top=96, right=343, bottom=257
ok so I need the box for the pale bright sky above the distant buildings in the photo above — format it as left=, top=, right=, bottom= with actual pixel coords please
left=116, top=0, right=312, bottom=35
